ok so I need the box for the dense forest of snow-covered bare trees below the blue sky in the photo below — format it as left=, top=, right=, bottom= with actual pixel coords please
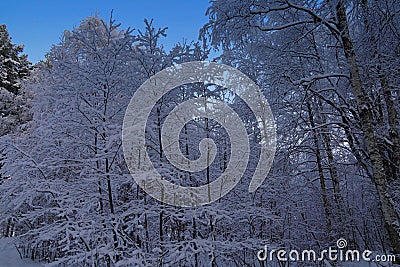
left=0, top=0, right=400, bottom=267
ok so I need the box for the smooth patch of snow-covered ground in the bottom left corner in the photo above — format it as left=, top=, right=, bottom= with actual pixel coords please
left=0, top=238, right=43, bottom=267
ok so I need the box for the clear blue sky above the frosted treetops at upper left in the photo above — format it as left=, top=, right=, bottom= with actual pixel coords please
left=0, top=0, right=209, bottom=63
